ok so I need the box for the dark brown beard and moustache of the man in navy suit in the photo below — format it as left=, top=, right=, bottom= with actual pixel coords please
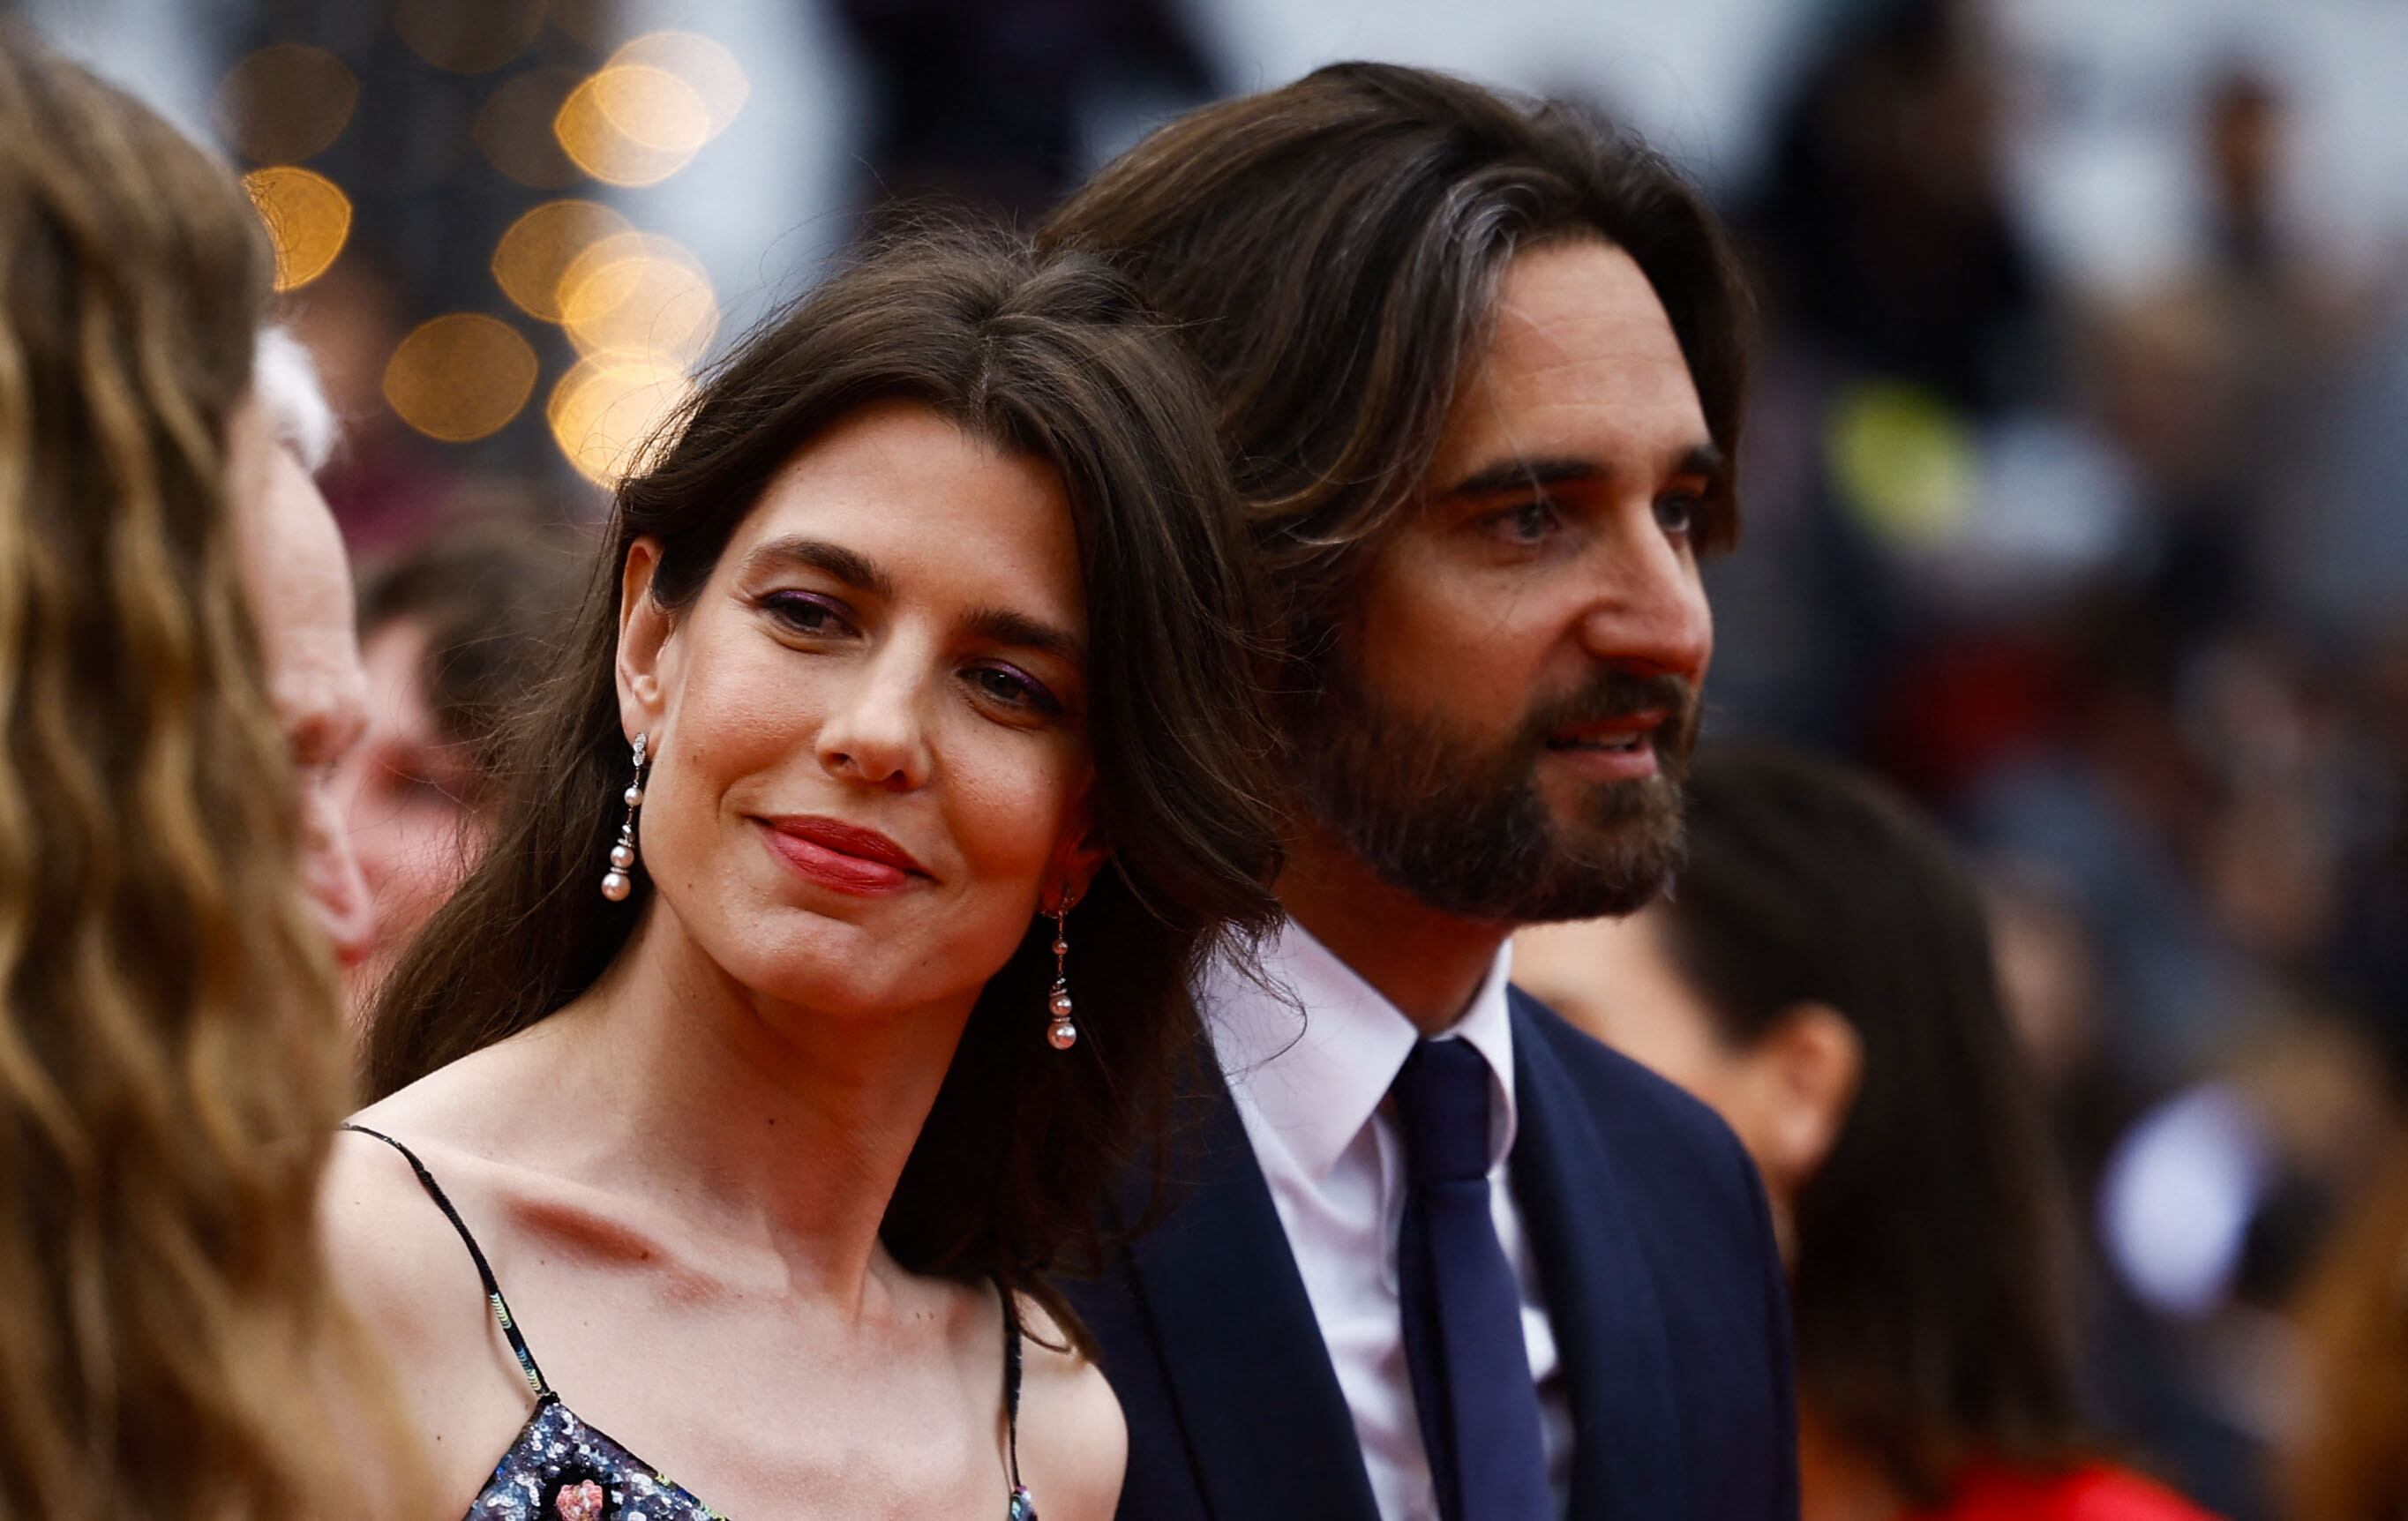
left=1291, top=657, right=1698, bottom=924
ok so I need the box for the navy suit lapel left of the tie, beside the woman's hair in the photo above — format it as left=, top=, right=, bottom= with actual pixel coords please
left=1129, top=1081, right=1377, bottom=1521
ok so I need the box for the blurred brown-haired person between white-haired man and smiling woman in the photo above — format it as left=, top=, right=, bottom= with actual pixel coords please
left=334, top=520, right=578, bottom=1015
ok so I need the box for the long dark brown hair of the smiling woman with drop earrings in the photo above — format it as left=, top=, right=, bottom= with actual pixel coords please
left=369, top=234, right=1276, bottom=1338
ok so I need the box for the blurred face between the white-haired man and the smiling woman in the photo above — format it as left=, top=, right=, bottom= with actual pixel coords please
left=334, top=618, right=489, bottom=1008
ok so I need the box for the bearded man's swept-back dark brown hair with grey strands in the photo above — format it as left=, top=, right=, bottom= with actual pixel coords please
left=1038, top=63, right=1746, bottom=669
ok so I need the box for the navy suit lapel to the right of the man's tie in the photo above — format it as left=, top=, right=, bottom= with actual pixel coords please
left=1510, top=992, right=1688, bottom=1521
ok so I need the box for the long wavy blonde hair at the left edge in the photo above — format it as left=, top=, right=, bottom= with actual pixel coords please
left=0, top=29, right=365, bottom=1521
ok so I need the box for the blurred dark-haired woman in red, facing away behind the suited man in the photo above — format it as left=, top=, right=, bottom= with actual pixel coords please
left=1515, top=746, right=2201, bottom=1521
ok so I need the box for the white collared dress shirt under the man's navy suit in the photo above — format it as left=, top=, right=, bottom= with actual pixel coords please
left=1204, top=922, right=1572, bottom=1521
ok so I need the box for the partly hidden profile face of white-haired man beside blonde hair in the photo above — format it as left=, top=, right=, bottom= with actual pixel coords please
left=227, top=400, right=373, bottom=965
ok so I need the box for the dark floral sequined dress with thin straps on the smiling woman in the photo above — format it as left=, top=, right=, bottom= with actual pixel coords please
left=344, top=1124, right=1038, bottom=1521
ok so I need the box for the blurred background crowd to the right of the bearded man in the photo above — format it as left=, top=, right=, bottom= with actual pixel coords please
left=1712, top=4, right=2408, bottom=1517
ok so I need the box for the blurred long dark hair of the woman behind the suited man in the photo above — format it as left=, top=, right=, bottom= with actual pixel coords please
left=1662, top=741, right=2095, bottom=1507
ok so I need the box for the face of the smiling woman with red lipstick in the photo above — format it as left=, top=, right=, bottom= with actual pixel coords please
left=626, top=404, right=1098, bottom=1030
